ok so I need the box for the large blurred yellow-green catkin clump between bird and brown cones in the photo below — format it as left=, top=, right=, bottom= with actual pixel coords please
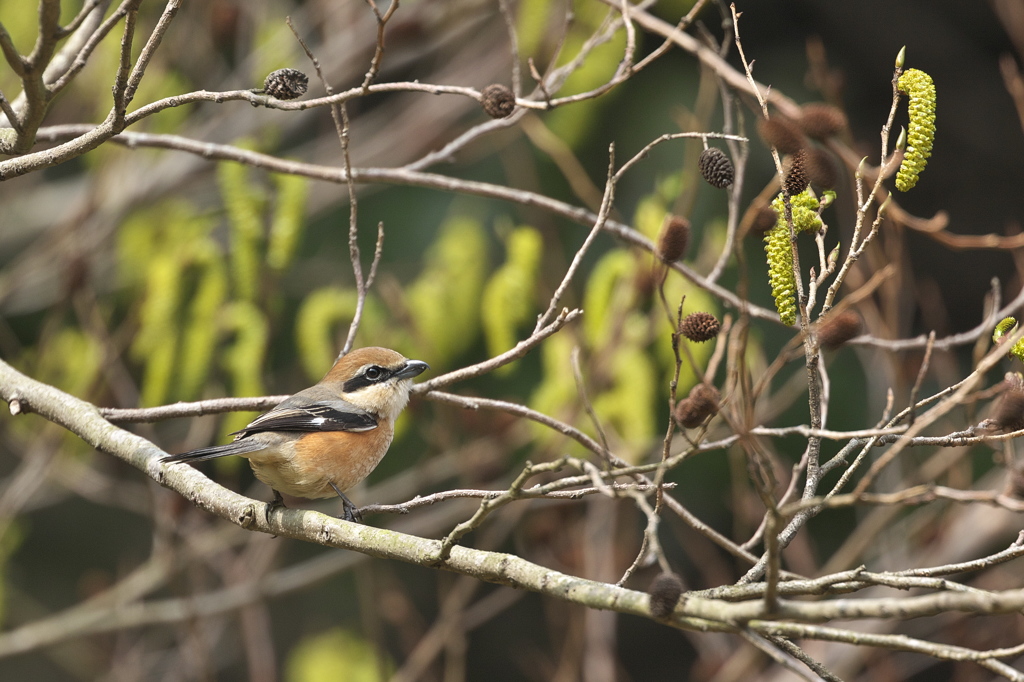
left=529, top=178, right=718, bottom=461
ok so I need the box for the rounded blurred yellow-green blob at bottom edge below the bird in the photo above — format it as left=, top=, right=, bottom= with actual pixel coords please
left=285, top=628, right=391, bottom=682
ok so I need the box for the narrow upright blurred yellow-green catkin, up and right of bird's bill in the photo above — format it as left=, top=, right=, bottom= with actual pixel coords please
left=481, top=226, right=544, bottom=374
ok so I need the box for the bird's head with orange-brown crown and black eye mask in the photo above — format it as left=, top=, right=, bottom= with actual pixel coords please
left=324, top=347, right=429, bottom=420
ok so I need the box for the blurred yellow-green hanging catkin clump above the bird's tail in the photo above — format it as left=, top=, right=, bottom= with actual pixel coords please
left=118, top=155, right=307, bottom=409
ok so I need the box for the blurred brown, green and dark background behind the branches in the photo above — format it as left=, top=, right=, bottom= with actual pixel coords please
left=0, top=0, right=1024, bottom=682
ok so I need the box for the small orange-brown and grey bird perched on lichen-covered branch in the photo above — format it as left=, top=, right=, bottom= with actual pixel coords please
left=161, top=346, right=429, bottom=521
